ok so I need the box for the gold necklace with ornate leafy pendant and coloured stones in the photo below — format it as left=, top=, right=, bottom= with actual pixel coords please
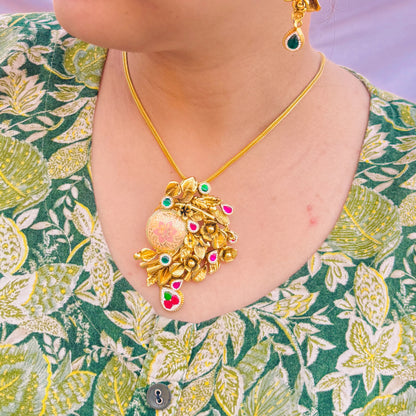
left=123, top=52, right=326, bottom=312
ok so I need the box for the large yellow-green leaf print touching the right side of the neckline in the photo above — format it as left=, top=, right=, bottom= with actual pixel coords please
left=328, top=185, right=402, bottom=263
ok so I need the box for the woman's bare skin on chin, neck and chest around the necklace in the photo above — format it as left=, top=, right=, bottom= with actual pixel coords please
left=55, top=0, right=369, bottom=322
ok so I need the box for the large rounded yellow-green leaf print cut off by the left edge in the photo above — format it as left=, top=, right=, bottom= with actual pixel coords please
left=0, top=136, right=50, bottom=215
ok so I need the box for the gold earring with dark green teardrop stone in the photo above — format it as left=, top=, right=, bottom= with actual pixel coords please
left=283, top=0, right=321, bottom=52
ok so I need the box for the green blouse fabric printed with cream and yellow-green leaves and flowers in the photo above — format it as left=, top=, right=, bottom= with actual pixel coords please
left=0, top=14, right=416, bottom=416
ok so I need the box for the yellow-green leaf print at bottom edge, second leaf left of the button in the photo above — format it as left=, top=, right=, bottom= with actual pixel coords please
left=44, top=355, right=95, bottom=416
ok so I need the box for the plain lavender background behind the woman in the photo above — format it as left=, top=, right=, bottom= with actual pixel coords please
left=0, top=0, right=416, bottom=102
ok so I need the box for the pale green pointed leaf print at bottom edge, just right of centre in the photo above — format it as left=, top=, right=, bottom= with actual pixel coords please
left=243, top=368, right=297, bottom=416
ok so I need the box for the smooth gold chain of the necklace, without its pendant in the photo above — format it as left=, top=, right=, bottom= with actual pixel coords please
left=123, top=52, right=326, bottom=182
